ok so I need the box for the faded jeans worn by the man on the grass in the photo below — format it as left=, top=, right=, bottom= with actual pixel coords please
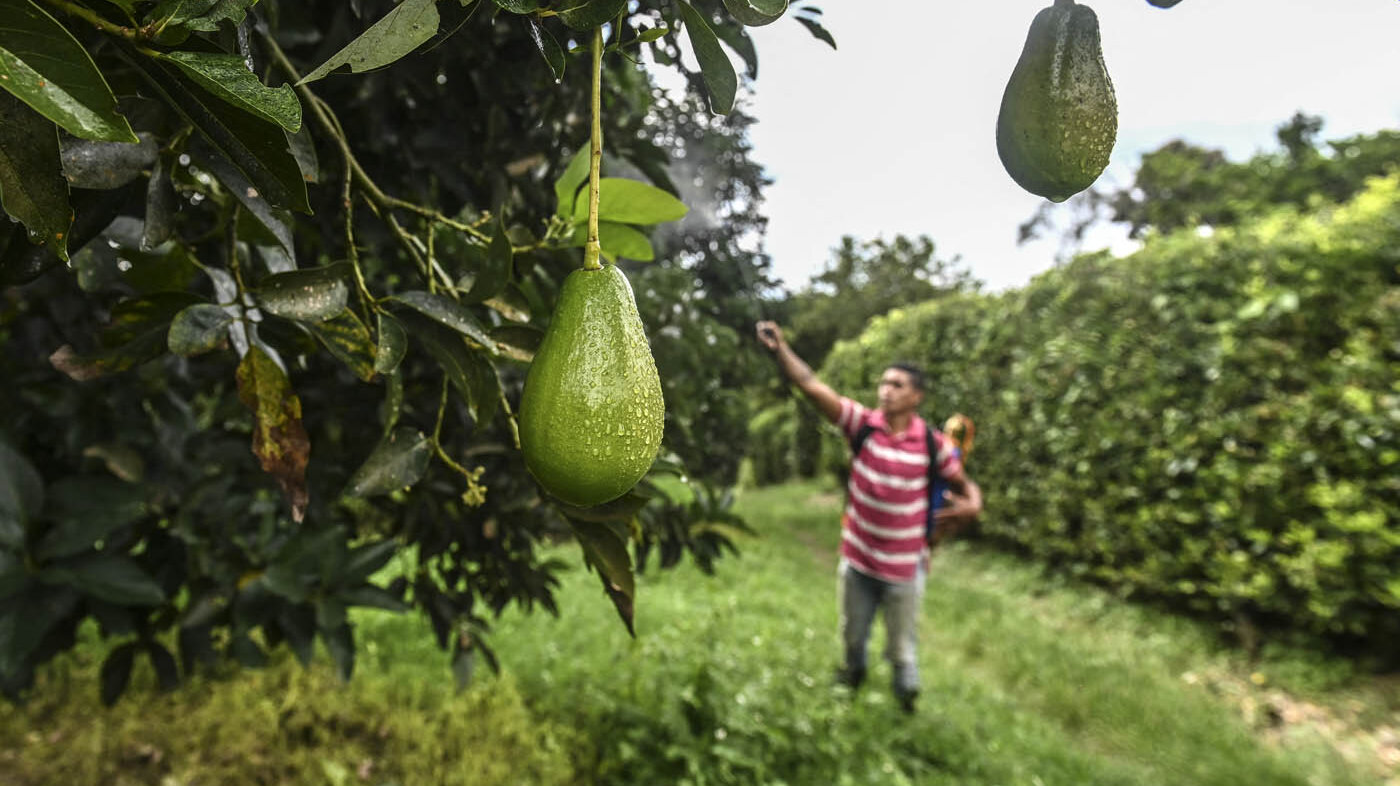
left=836, top=559, right=927, bottom=696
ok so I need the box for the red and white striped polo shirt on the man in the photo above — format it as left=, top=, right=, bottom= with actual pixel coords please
left=836, top=398, right=962, bottom=581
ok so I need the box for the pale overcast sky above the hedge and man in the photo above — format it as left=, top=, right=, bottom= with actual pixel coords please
left=748, top=0, right=1400, bottom=290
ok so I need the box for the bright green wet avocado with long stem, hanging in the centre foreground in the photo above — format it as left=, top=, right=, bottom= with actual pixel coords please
left=519, top=28, right=665, bottom=507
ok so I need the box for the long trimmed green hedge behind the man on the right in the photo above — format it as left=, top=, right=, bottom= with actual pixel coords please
left=817, top=177, right=1400, bottom=643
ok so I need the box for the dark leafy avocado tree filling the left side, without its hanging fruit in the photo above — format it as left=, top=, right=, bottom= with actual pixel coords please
left=0, top=0, right=819, bottom=701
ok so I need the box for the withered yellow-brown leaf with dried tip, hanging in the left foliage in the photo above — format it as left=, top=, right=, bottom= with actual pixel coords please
left=238, top=346, right=311, bottom=521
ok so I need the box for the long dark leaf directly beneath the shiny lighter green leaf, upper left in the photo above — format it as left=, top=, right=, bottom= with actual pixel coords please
left=120, top=43, right=311, bottom=213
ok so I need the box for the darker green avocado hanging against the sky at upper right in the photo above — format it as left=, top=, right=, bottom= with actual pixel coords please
left=997, top=0, right=1119, bottom=202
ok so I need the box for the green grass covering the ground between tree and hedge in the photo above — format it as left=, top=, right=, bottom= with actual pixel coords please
left=0, top=485, right=1400, bottom=786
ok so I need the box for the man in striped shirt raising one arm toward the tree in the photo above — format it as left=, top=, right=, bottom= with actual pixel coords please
left=757, top=316, right=981, bottom=712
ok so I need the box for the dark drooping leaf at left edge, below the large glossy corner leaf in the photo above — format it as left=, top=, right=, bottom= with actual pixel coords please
left=0, top=92, right=73, bottom=261
